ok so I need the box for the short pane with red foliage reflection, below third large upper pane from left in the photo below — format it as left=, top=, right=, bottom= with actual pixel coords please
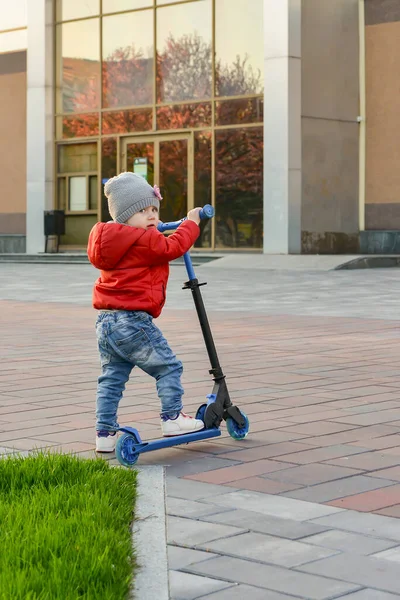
left=157, top=102, right=211, bottom=129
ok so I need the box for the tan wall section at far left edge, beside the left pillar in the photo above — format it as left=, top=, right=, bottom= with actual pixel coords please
left=0, top=51, right=26, bottom=234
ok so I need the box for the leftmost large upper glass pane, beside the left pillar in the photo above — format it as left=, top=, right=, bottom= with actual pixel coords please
left=57, top=19, right=100, bottom=113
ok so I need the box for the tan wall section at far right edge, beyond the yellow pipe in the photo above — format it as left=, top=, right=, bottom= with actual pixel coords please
left=365, top=0, right=400, bottom=230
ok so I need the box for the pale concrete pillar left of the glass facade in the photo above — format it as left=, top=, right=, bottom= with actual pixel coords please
left=26, top=0, right=54, bottom=254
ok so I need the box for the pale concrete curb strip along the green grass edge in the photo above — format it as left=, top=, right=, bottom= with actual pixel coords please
left=129, top=466, right=170, bottom=600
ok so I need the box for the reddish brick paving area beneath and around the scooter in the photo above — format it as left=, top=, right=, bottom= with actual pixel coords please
left=0, top=301, right=400, bottom=517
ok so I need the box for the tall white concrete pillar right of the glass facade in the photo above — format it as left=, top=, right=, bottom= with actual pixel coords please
left=264, top=0, right=301, bottom=254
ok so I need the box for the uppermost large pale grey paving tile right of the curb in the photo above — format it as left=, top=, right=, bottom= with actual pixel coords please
left=206, top=490, right=343, bottom=521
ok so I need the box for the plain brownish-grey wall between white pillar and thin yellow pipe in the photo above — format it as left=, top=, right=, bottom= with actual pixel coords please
left=302, top=0, right=359, bottom=253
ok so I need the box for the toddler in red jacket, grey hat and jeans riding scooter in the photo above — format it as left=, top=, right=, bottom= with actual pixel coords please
left=88, top=173, right=204, bottom=452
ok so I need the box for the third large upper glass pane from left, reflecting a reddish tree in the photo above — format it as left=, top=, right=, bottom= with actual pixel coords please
left=157, top=0, right=212, bottom=102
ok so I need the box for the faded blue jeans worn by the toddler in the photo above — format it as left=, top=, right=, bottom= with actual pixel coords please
left=96, top=310, right=183, bottom=431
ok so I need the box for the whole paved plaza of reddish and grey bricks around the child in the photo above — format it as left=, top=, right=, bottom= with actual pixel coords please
left=0, top=265, right=400, bottom=600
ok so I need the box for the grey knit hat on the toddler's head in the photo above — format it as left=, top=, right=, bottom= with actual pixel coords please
left=104, top=173, right=162, bottom=223
